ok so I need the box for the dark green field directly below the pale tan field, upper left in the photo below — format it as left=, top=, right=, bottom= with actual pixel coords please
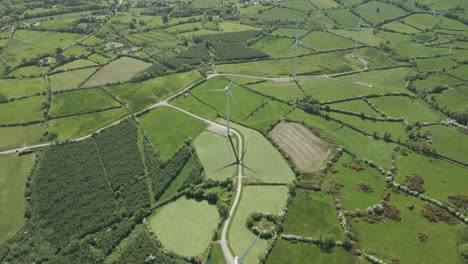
left=49, top=88, right=119, bottom=116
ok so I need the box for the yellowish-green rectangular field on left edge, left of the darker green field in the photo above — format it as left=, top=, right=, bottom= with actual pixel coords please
left=0, top=78, right=46, bottom=98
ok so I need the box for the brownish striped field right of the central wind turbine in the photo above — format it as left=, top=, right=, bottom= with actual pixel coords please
left=270, top=123, right=330, bottom=172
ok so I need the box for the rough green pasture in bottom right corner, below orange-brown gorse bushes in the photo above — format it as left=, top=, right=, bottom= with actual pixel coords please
left=352, top=193, right=466, bottom=263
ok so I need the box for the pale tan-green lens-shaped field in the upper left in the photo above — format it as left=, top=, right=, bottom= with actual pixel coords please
left=83, top=57, right=151, bottom=87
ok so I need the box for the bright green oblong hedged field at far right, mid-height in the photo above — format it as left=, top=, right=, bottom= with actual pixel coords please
left=370, top=96, right=446, bottom=123
